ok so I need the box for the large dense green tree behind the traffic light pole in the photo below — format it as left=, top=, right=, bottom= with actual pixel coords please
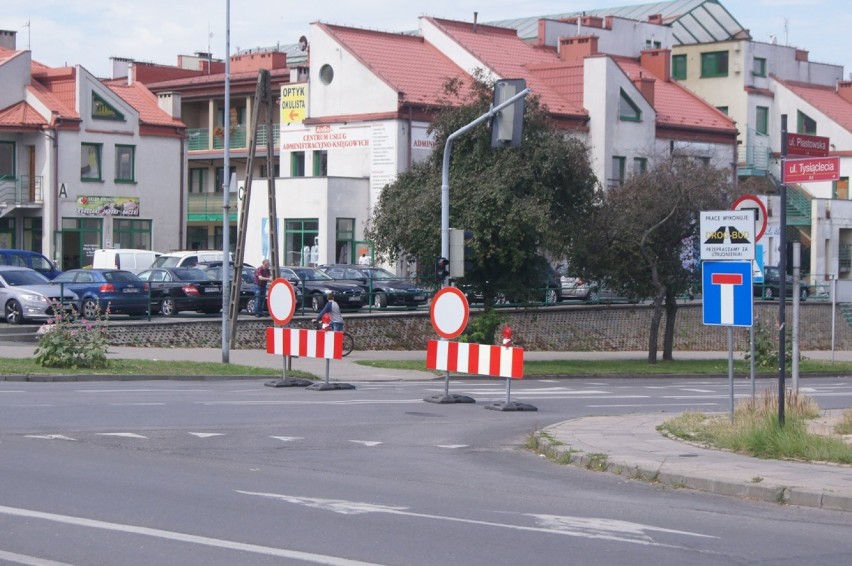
left=366, top=78, right=597, bottom=305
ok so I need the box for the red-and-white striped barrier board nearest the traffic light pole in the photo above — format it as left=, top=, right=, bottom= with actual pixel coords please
left=426, top=340, right=524, bottom=379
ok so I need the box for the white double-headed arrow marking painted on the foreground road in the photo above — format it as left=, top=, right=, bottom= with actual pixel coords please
left=237, top=490, right=718, bottom=548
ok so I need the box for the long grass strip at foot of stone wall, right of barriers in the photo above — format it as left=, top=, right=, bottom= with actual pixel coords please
left=356, top=359, right=852, bottom=377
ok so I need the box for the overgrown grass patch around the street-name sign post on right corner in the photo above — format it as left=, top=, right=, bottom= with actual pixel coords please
left=658, top=391, right=852, bottom=464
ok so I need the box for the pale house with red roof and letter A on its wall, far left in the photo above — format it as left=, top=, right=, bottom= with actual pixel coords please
left=0, top=32, right=186, bottom=269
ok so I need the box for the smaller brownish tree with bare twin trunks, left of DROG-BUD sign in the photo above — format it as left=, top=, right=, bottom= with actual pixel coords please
left=571, top=156, right=733, bottom=364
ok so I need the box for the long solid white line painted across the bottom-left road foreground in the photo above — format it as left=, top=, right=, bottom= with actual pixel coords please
left=0, top=506, right=382, bottom=566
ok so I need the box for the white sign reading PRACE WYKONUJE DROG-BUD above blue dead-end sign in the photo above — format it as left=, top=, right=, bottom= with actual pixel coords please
left=701, top=210, right=755, bottom=261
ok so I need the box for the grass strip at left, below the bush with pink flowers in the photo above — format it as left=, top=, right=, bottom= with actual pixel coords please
left=0, top=358, right=306, bottom=379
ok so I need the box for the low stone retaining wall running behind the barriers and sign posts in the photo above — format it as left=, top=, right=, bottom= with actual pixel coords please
left=101, top=302, right=852, bottom=351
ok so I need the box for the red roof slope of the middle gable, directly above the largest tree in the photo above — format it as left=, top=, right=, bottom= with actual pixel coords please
left=427, top=18, right=587, bottom=117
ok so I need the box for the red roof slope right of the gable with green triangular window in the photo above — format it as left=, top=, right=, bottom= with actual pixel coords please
left=613, top=57, right=736, bottom=133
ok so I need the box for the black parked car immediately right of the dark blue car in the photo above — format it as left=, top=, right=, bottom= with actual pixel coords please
left=139, top=267, right=222, bottom=316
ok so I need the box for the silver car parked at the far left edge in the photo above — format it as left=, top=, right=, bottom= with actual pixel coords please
left=0, top=265, right=77, bottom=324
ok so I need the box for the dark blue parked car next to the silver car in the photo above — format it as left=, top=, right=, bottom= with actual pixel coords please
left=52, top=269, right=148, bottom=319
